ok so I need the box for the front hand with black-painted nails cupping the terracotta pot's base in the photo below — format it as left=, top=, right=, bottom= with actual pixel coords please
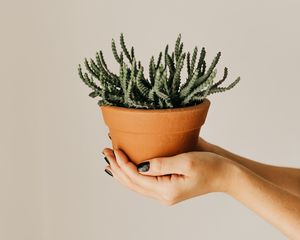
left=103, top=148, right=227, bottom=205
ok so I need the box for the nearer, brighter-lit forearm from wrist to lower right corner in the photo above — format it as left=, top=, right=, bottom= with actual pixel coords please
left=222, top=160, right=300, bottom=239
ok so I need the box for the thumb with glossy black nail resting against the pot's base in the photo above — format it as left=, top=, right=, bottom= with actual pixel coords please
left=137, top=154, right=189, bottom=176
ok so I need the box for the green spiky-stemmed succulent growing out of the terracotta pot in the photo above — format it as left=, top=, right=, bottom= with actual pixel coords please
left=78, top=33, right=240, bottom=109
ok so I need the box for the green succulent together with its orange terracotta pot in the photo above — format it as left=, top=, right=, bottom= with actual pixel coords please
left=78, top=33, right=240, bottom=164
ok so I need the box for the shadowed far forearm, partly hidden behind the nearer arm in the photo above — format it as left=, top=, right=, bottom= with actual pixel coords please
left=199, top=141, right=300, bottom=196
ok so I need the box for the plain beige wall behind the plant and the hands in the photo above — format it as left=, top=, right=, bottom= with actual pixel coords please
left=0, top=0, right=300, bottom=240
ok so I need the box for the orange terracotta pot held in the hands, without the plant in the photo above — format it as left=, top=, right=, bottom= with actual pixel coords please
left=100, top=99, right=210, bottom=164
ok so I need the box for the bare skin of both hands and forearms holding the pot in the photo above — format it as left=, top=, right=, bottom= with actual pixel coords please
left=103, top=138, right=300, bottom=239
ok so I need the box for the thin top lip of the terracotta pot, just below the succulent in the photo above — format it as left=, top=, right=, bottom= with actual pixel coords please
left=100, top=98, right=210, bottom=113
